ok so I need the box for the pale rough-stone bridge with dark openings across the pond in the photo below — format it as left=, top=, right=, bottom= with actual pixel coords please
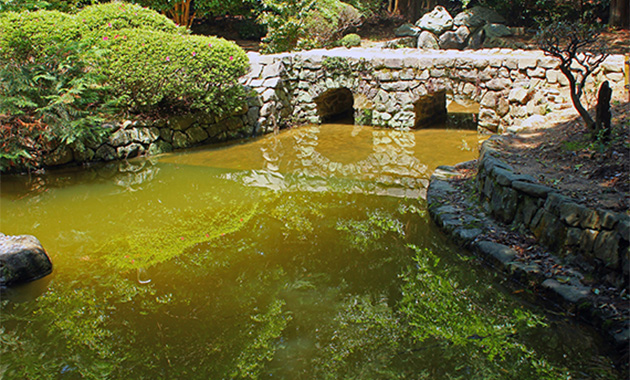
left=241, top=48, right=627, bottom=133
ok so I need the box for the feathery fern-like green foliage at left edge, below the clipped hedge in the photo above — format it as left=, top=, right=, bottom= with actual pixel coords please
left=0, top=42, right=111, bottom=171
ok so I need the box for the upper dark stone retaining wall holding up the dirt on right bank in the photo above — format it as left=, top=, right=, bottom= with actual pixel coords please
left=477, top=136, right=630, bottom=285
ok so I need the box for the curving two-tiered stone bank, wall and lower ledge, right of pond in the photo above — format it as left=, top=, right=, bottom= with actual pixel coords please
left=427, top=136, right=630, bottom=367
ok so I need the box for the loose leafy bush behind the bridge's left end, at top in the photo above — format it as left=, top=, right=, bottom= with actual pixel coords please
left=259, top=0, right=361, bottom=53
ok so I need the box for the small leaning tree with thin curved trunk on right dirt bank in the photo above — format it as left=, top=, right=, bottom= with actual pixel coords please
left=537, top=21, right=609, bottom=131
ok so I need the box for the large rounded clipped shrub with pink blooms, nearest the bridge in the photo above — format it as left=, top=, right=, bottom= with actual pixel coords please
left=99, top=29, right=249, bottom=114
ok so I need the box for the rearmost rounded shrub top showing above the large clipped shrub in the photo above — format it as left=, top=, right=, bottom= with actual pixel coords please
left=76, top=2, right=186, bottom=34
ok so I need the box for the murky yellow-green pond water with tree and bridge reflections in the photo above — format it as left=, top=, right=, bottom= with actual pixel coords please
left=0, top=125, right=619, bottom=379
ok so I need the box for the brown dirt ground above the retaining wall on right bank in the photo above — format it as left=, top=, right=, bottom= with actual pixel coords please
left=504, top=102, right=630, bottom=213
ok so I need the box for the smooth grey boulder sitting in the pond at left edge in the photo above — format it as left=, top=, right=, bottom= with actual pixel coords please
left=0, top=233, right=52, bottom=286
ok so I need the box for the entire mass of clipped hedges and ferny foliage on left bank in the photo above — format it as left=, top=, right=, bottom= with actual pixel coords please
left=0, top=3, right=248, bottom=171
